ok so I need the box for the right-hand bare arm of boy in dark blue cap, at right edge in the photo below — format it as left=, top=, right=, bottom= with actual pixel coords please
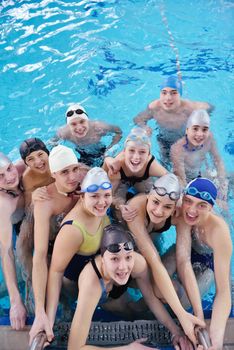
left=210, top=221, right=232, bottom=350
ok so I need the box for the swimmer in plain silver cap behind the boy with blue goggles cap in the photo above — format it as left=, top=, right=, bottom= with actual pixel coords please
left=170, top=109, right=228, bottom=205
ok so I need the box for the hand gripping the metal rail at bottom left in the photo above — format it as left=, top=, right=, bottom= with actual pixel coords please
left=29, top=312, right=54, bottom=345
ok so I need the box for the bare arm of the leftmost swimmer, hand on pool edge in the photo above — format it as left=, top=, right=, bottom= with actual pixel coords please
left=0, top=203, right=26, bottom=330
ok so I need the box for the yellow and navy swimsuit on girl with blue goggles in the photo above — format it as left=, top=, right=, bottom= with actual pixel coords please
left=60, top=216, right=110, bottom=282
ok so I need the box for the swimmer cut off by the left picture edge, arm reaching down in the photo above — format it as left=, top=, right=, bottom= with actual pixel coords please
left=0, top=152, right=26, bottom=330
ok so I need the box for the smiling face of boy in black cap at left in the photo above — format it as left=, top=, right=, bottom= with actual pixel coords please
left=25, top=150, right=49, bottom=174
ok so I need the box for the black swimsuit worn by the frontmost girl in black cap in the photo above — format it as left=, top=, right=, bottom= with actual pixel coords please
left=91, top=258, right=132, bottom=305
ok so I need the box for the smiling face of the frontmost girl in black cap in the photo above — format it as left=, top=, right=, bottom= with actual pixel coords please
left=102, top=247, right=134, bottom=285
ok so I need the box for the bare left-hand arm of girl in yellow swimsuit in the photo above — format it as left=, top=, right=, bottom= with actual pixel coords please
left=46, top=225, right=83, bottom=326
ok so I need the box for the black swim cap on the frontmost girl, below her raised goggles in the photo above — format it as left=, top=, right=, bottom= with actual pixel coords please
left=100, top=224, right=135, bottom=256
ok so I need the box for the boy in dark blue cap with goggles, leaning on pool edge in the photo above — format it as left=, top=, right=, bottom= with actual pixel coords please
left=176, top=178, right=232, bottom=350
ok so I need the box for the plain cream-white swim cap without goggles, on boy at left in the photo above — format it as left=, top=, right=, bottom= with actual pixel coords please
left=49, top=145, right=78, bottom=173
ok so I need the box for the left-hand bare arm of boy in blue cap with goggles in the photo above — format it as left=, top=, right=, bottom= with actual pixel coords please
left=176, top=221, right=204, bottom=319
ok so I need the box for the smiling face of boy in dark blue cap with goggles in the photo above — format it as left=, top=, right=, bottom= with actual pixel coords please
left=182, top=195, right=212, bottom=226
